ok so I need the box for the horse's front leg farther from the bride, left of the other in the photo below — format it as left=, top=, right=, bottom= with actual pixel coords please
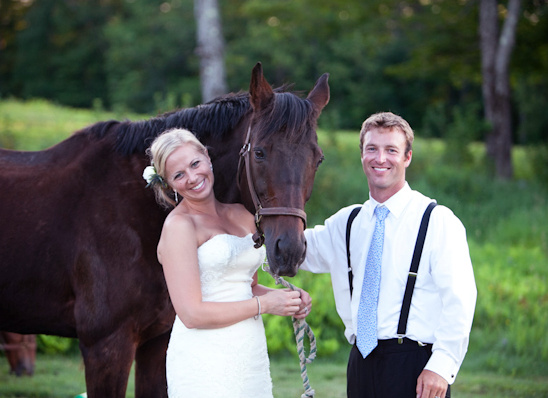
left=80, top=331, right=135, bottom=398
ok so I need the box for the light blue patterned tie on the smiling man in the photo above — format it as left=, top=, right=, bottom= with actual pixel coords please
left=357, top=206, right=389, bottom=358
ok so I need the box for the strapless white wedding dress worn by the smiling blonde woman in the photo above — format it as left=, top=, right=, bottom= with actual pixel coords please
left=166, top=234, right=272, bottom=398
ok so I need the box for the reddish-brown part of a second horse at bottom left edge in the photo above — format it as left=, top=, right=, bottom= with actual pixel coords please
left=0, top=332, right=36, bottom=377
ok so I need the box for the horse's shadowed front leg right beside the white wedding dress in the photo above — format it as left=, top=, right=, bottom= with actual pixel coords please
left=135, top=332, right=170, bottom=398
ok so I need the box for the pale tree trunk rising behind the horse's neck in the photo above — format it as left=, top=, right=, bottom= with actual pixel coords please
left=194, top=0, right=228, bottom=102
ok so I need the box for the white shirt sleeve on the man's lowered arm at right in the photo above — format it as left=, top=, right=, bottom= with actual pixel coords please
left=425, top=206, right=477, bottom=384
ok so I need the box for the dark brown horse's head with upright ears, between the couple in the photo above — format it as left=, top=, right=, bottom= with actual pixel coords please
left=239, top=63, right=329, bottom=276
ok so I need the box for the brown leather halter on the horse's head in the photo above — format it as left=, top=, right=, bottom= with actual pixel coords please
left=237, top=126, right=306, bottom=248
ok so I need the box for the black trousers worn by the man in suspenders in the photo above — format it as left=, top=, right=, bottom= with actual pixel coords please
left=346, top=339, right=451, bottom=398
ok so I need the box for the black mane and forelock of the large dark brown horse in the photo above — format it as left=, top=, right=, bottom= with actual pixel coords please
left=81, top=85, right=312, bottom=155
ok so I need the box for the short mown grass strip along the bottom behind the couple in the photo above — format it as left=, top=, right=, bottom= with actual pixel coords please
left=0, top=348, right=548, bottom=398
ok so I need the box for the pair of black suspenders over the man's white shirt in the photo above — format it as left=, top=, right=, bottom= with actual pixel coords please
left=346, top=202, right=436, bottom=342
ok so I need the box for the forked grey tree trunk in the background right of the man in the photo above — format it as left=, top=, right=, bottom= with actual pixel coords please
left=479, top=0, right=521, bottom=179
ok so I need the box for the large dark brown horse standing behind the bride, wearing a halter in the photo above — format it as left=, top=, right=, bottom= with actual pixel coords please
left=0, top=63, right=329, bottom=398
